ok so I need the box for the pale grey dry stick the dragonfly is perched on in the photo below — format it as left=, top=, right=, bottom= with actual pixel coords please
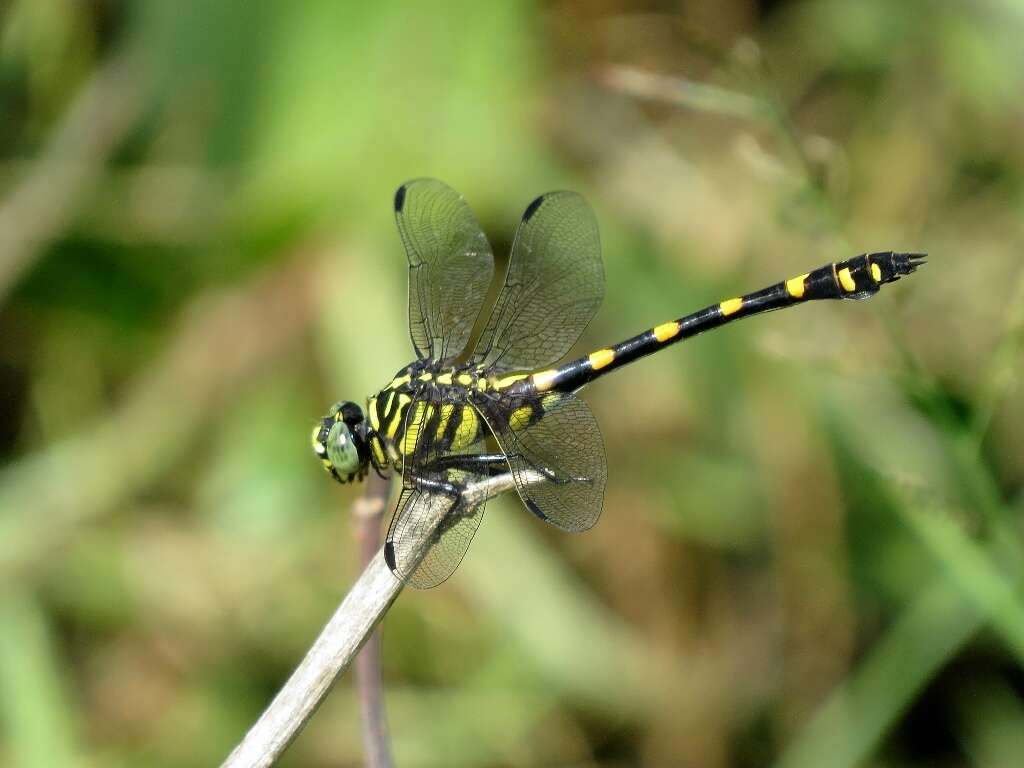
left=221, top=471, right=545, bottom=768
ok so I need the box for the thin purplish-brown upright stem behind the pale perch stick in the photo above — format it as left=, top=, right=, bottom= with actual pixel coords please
left=352, top=472, right=394, bottom=768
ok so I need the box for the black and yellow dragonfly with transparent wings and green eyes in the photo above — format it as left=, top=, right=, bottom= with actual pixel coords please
left=312, top=178, right=926, bottom=588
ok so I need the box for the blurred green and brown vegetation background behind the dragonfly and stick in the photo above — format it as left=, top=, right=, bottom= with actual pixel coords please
left=0, top=0, right=1024, bottom=768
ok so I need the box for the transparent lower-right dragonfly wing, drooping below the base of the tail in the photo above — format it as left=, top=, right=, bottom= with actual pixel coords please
left=480, top=392, right=608, bottom=531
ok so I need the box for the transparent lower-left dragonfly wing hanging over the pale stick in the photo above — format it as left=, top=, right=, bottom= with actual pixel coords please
left=384, top=391, right=485, bottom=589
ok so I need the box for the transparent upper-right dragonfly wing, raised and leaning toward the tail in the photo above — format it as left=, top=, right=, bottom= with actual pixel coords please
left=473, top=191, right=604, bottom=371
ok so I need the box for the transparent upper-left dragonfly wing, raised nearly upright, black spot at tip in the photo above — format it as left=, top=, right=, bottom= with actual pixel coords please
left=394, top=179, right=495, bottom=361
